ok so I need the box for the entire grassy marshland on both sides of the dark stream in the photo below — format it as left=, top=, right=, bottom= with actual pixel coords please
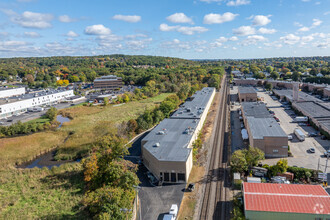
left=0, top=94, right=170, bottom=219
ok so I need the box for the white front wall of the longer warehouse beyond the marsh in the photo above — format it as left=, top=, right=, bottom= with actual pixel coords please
left=0, top=90, right=74, bottom=118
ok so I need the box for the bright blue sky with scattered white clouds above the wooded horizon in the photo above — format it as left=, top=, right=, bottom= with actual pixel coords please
left=0, top=0, right=330, bottom=59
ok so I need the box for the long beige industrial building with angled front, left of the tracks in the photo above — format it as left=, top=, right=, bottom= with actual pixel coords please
left=141, top=87, right=215, bottom=183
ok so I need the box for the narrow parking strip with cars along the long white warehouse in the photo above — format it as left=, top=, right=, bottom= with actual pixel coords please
left=0, top=100, right=86, bottom=126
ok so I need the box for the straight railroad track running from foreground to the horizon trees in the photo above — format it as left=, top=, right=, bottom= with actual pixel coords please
left=199, top=74, right=230, bottom=220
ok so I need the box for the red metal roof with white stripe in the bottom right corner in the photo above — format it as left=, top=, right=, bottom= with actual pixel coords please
left=243, top=183, right=330, bottom=214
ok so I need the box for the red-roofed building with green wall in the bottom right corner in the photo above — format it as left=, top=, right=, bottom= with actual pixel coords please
left=242, top=182, right=330, bottom=220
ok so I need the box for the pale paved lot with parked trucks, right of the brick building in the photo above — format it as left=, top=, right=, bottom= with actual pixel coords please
left=258, top=91, right=330, bottom=171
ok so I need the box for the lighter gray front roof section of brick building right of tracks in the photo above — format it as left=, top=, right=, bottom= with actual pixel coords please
left=247, top=117, right=288, bottom=139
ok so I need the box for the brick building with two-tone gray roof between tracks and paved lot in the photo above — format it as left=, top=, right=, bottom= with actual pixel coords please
left=242, top=102, right=288, bottom=158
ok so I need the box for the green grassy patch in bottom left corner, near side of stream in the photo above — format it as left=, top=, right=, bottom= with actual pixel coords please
left=0, top=163, right=87, bottom=219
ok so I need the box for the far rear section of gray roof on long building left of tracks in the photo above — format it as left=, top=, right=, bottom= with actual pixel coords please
left=171, top=87, right=215, bottom=119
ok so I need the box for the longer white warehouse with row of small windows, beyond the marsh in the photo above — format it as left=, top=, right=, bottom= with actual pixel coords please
left=0, top=90, right=74, bottom=119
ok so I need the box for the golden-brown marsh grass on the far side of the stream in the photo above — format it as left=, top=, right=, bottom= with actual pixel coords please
left=0, top=94, right=170, bottom=167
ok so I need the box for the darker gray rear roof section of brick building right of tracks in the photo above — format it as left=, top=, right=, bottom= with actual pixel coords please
left=242, top=102, right=272, bottom=118
